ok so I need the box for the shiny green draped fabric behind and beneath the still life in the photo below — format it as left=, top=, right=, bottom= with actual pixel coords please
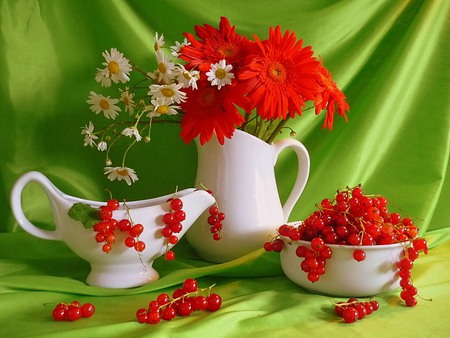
left=0, top=0, right=450, bottom=337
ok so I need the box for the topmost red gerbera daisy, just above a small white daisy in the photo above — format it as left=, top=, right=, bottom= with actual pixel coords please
left=180, top=17, right=254, bottom=72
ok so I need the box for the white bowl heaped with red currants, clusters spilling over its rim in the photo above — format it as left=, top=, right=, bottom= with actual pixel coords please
left=264, top=186, right=427, bottom=298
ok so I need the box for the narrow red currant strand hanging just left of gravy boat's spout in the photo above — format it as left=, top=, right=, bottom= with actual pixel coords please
left=161, top=198, right=186, bottom=261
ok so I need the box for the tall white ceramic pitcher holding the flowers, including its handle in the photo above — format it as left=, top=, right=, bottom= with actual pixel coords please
left=186, top=130, right=310, bottom=262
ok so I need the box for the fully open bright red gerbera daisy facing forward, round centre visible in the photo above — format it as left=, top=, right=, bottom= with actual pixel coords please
left=239, top=26, right=320, bottom=120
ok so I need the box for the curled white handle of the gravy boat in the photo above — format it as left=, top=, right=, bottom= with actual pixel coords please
left=11, top=171, right=60, bottom=240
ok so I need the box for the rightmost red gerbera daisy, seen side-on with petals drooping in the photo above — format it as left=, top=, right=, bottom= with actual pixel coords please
left=314, top=64, right=350, bottom=130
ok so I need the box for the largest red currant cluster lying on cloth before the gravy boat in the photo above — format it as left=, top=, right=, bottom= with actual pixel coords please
left=136, top=278, right=222, bottom=324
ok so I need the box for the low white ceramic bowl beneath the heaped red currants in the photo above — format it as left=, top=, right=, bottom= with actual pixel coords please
left=280, top=237, right=404, bottom=297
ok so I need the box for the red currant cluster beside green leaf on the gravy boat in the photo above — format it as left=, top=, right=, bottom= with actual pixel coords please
left=94, top=198, right=145, bottom=253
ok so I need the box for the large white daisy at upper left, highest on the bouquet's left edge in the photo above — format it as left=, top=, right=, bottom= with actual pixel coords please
left=95, top=48, right=132, bottom=87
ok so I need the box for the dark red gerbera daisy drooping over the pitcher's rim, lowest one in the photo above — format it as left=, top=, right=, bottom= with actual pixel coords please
left=181, top=81, right=248, bottom=145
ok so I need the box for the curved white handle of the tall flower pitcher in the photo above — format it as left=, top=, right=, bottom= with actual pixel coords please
left=272, top=139, right=310, bottom=222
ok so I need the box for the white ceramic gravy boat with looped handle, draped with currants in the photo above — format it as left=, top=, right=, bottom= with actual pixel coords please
left=11, top=171, right=215, bottom=288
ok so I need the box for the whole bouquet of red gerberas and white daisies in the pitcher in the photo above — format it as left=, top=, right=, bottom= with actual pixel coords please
left=81, top=17, right=349, bottom=185
